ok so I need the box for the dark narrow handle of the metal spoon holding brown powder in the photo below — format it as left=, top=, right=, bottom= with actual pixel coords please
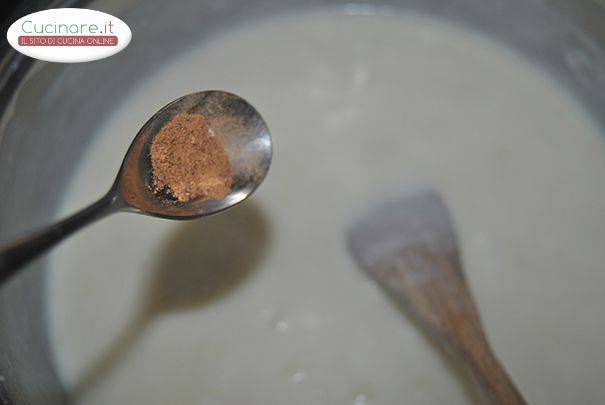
left=0, top=192, right=122, bottom=285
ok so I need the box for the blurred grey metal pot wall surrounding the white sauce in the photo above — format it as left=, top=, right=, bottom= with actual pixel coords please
left=0, top=0, right=605, bottom=404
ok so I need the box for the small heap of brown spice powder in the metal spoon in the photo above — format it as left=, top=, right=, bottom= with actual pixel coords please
left=150, top=114, right=233, bottom=202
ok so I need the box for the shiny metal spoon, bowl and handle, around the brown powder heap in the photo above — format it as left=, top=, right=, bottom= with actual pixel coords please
left=0, top=91, right=272, bottom=283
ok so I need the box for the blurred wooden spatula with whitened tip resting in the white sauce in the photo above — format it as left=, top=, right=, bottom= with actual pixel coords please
left=348, top=189, right=525, bottom=404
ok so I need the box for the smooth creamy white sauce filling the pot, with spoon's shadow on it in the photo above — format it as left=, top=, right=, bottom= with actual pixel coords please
left=48, top=10, right=605, bottom=405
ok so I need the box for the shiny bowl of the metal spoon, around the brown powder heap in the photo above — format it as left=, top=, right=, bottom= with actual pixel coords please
left=114, top=90, right=272, bottom=219
